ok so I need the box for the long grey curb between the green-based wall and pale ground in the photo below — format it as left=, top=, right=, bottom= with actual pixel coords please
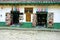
left=0, top=27, right=60, bottom=32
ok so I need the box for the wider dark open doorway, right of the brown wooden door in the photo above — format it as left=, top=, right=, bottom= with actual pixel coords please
left=37, top=12, right=47, bottom=27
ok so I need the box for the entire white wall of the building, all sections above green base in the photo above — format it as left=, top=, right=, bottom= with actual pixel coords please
left=0, top=6, right=60, bottom=23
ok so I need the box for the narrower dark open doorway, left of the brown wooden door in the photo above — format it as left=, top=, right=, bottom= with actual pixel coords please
left=11, top=11, right=19, bottom=24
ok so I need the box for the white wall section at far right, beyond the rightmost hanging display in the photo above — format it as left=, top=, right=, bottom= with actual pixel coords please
left=48, top=8, right=60, bottom=23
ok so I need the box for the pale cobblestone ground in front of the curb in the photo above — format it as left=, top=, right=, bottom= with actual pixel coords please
left=0, top=30, right=60, bottom=40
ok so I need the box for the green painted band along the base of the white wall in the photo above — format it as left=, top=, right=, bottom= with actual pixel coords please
left=0, top=22, right=60, bottom=29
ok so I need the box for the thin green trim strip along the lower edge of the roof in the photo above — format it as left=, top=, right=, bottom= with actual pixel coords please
left=0, top=2, right=60, bottom=5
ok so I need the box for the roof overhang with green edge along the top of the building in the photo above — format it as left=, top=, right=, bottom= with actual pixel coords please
left=0, top=0, right=60, bottom=5
